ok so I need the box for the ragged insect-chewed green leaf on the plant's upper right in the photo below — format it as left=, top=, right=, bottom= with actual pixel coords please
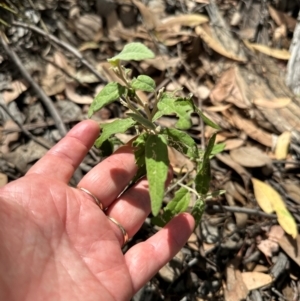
left=152, top=93, right=193, bottom=130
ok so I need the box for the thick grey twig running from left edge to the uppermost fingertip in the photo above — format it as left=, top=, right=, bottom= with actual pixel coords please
left=0, top=34, right=67, bottom=137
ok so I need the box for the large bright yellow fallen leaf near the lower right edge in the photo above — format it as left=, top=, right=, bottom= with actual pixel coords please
left=251, top=178, right=298, bottom=238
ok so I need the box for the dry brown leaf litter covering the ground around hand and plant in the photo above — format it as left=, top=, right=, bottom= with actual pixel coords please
left=0, top=0, right=300, bottom=301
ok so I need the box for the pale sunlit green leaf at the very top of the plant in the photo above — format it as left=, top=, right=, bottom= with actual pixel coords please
left=108, top=43, right=155, bottom=63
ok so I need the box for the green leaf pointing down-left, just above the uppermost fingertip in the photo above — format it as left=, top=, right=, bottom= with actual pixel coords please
left=88, top=82, right=126, bottom=118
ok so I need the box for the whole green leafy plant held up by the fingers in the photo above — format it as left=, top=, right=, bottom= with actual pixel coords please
left=88, top=43, right=223, bottom=226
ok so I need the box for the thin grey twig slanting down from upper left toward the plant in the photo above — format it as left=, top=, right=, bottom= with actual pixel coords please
left=12, top=21, right=107, bottom=83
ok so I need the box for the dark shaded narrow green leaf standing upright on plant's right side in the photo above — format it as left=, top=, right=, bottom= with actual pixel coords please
left=195, top=133, right=217, bottom=195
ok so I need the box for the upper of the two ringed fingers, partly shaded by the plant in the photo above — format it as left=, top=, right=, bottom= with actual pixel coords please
left=78, top=145, right=137, bottom=208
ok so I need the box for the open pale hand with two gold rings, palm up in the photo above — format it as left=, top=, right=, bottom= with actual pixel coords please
left=0, top=121, right=194, bottom=301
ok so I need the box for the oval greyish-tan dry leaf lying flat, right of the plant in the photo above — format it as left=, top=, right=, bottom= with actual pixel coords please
left=230, top=146, right=272, bottom=167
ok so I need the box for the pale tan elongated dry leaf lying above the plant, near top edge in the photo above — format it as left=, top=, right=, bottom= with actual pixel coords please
left=156, top=14, right=209, bottom=31
